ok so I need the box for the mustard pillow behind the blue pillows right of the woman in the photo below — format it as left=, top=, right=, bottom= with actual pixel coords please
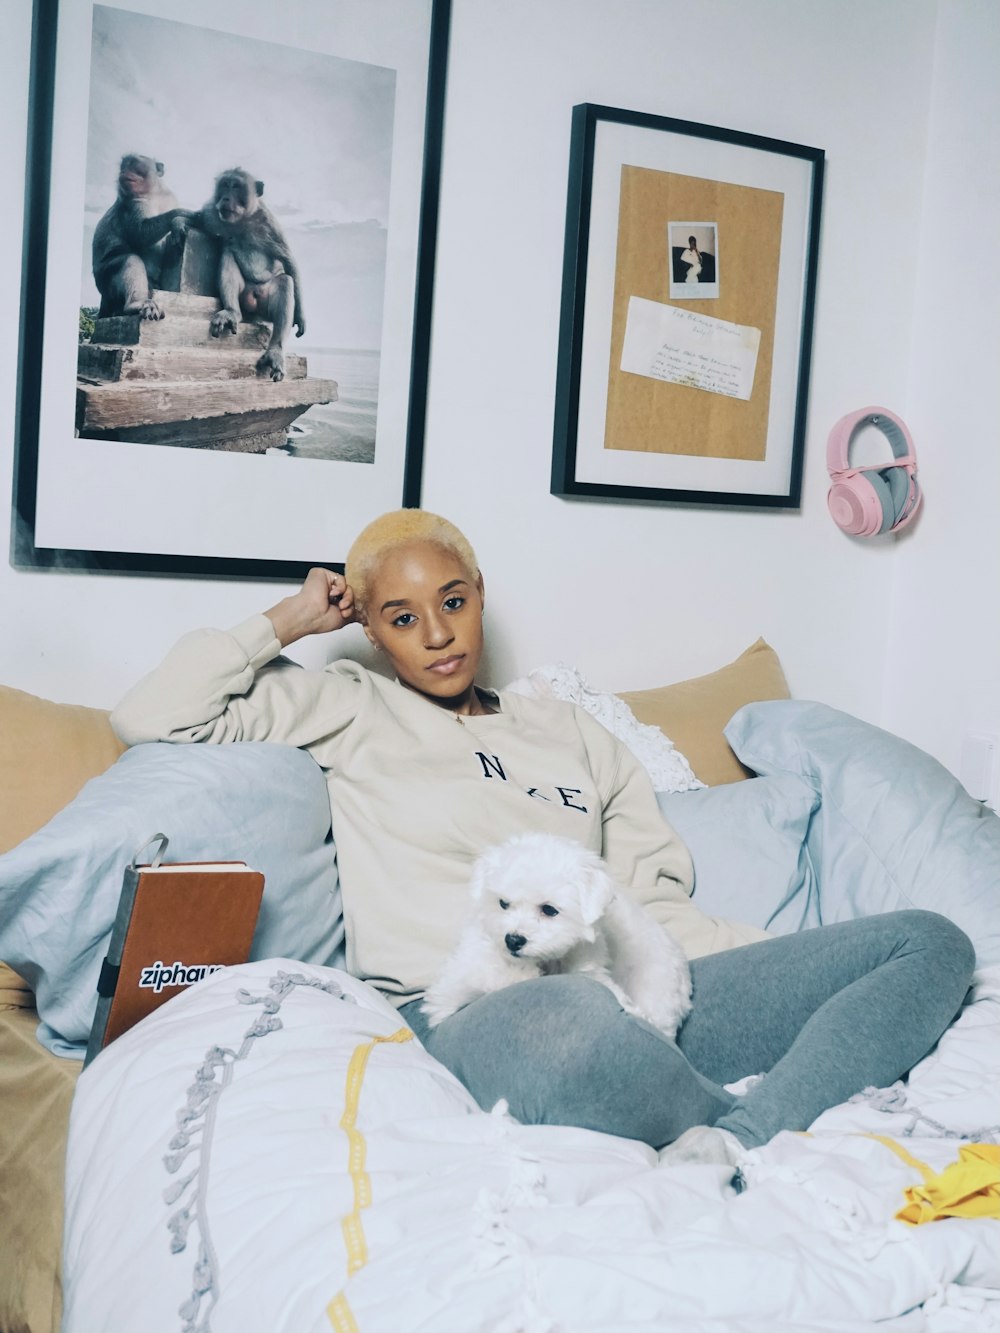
left=619, top=639, right=791, bottom=786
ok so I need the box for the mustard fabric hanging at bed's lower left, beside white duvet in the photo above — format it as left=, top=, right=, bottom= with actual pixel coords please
left=0, top=1009, right=81, bottom=1333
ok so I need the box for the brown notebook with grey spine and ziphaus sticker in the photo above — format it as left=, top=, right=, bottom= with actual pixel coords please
left=84, top=833, right=264, bottom=1068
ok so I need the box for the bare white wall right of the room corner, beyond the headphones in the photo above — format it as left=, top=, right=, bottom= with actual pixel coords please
left=884, top=0, right=1000, bottom=778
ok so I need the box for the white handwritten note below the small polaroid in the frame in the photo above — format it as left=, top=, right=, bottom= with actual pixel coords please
left=621, top=296, right=760, bottom=400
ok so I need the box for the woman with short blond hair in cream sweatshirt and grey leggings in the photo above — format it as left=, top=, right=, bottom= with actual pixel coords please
left=112, top=509, right=973, bottom=1168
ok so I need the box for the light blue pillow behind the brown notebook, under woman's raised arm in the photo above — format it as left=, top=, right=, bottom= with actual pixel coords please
left=0, top=741, right=344, bottom=1058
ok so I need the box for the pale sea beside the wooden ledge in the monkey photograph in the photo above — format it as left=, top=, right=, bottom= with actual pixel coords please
left=281, top=347, right=380, bottom=463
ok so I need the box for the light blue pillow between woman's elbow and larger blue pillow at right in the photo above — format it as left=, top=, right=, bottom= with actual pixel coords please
left=656, top=774, right=819, bottom=934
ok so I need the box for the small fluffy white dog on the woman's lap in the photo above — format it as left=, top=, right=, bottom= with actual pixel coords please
left=423, top=833, right=691, bottom=1038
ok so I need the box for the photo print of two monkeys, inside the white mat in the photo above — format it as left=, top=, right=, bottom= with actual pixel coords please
left=77, top=4, right=404, bottom=464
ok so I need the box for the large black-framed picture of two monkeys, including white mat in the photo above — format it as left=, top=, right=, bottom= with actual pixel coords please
left=12, top=0, right=449, bottom=579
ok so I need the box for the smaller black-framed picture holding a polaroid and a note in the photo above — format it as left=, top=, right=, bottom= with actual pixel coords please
left=551, top=103, right=825, bottom=508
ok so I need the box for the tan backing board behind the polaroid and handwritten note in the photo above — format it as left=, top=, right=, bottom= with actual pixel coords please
left=604, top=167, right=784, bottom=461
